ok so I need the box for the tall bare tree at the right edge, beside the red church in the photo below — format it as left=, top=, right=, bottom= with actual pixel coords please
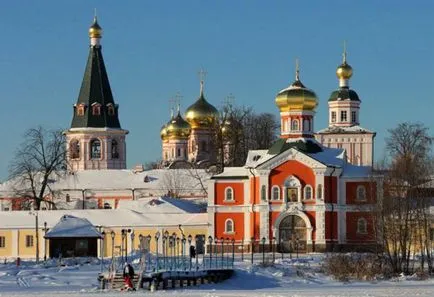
left=380, top=123, right=433, bottom=273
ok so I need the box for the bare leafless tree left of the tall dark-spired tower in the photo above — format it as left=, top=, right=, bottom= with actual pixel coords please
left=9, top=127, right=66, bottom=210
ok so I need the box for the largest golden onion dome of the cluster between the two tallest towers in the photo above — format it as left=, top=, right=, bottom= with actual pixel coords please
left=185, top=87, right=219, bottom=129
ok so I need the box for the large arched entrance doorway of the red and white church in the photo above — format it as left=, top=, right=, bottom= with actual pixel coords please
left=279, top=215, right=307, bottom=253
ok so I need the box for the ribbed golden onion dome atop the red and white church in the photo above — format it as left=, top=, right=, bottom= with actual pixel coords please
left=275, top=67, right=318, bottom=112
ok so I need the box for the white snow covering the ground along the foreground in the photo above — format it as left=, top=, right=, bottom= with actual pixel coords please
left=0, top=255, right=434, bottom=297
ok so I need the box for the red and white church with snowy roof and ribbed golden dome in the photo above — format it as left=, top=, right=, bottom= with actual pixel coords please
left=208, top=60, right=382, bottom=252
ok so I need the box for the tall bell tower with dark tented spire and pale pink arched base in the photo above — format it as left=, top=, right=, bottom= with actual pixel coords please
left=65, top=15, right=128, bottom=171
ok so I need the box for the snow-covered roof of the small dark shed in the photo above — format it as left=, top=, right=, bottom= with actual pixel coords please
left=45, top=215, right=101, bottom=238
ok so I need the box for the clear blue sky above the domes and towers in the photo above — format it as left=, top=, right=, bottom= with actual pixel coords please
left=0, top=0, right=434, bottom=180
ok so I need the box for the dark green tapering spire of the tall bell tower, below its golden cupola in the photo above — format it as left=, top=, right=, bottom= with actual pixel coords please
left=71, top=43, right=121, bottom=129
